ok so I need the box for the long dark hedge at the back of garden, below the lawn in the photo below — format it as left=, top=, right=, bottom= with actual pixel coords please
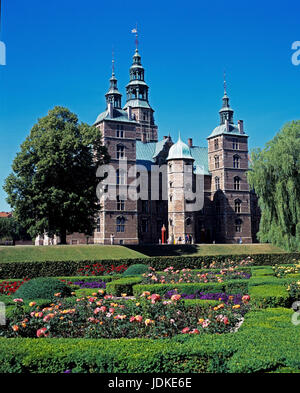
left=0, top=253, right=300, bottom=278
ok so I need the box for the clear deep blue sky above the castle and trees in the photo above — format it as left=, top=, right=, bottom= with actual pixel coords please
left=0, top=0, right=300, bottom=211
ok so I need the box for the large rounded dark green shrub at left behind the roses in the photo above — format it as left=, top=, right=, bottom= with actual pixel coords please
left=15, top=277, right=71, bottom=299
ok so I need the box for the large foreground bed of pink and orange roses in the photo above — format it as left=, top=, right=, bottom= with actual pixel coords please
left=0, top=290, right=249, bottom=338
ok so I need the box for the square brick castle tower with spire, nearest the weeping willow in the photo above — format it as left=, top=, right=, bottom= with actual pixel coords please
left=207, top=82, right=252, bottom=243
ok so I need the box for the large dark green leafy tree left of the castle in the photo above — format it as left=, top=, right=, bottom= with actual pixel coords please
left=3, top=107, right=109, bottom=244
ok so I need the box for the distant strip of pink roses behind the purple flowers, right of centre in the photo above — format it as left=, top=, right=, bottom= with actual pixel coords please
left=142, top=266, right=251, bottom=284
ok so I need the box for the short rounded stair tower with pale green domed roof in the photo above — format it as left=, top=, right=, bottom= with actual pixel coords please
left=167, top=136, right=195, bottom=243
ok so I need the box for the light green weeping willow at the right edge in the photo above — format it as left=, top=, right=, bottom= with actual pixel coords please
left=248, top=120, right=300, bottom=251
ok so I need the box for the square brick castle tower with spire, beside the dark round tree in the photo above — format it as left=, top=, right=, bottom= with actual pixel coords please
left=94, top=59, right=138, bottom=244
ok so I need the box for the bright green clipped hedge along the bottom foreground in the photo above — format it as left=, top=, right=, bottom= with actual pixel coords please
left=0, top=308, right=300, bottom=373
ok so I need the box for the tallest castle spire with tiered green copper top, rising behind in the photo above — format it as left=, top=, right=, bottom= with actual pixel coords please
left=123, top=49, right=158, bottom=142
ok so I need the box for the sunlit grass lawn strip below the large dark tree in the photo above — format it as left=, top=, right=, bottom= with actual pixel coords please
left=0, top=245, right=145, bottom=263
